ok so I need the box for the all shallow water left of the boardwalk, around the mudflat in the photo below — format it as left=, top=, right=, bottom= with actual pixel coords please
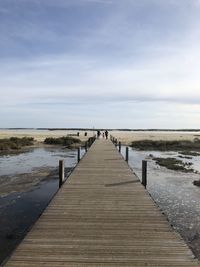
left=0, top=148, right=84, bottom=264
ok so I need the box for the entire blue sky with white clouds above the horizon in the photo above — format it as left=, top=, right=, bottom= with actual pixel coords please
left=0, top=0, right=200, bottom=129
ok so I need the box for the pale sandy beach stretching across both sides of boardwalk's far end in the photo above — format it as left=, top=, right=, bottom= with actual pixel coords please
left=0, top=129, right=200, bottom=145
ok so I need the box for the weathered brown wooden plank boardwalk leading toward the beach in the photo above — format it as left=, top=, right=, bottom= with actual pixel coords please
left=5, top=140, right=199, bottom=267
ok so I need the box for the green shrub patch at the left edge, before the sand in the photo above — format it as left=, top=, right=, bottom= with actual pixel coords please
left=0, top=137, right=34, bottom=152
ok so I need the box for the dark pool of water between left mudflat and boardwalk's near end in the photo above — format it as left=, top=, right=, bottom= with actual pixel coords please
left=0, top=179, right=58, bottom=263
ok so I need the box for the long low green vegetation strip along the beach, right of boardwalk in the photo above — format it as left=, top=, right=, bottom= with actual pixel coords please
left=131, top=138, right=200, bottom=151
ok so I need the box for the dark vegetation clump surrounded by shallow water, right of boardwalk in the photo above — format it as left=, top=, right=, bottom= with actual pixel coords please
left=153, top=158, right=194, bottom=172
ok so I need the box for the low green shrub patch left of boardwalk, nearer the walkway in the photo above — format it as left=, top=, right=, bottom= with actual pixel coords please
left=44, top=136, right=81, bottom=148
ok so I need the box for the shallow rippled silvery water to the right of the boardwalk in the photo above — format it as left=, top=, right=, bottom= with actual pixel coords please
left=122, top=147, right=200, bottom=259
